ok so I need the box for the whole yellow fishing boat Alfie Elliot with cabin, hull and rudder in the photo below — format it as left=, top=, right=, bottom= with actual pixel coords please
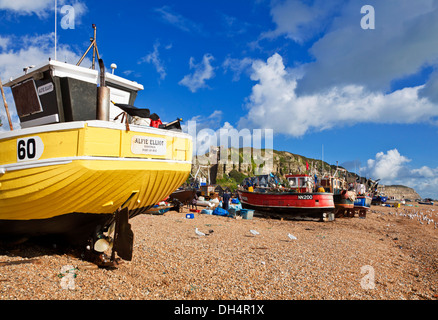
left=0, top=28, right=192, bottom=268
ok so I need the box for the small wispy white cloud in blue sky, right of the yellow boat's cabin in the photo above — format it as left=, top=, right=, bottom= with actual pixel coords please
left=179, top=54, right=214, bottom=92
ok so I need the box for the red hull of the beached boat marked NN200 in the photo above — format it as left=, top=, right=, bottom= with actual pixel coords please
left=238, top=190, right=335, bottom=220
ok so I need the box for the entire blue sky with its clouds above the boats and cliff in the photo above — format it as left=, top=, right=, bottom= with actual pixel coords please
left=0, top=0, right=438, bottom=198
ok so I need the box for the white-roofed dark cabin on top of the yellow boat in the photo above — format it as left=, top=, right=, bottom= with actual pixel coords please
left=4, top=60, right=143, bottom=128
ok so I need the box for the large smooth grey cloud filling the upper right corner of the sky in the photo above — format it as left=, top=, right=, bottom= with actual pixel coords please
left=257, top=0, right=438, bottom=102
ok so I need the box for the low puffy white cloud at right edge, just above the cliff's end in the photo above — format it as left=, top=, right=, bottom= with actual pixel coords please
left=360, top=149, right=438, bottom=198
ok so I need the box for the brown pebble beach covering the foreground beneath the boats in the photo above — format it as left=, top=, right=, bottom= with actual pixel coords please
left=0, top=205, right=438, bottom=300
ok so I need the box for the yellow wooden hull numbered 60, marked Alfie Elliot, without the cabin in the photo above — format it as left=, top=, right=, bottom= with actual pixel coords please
left=0, top=121, right=191, bottom=243
